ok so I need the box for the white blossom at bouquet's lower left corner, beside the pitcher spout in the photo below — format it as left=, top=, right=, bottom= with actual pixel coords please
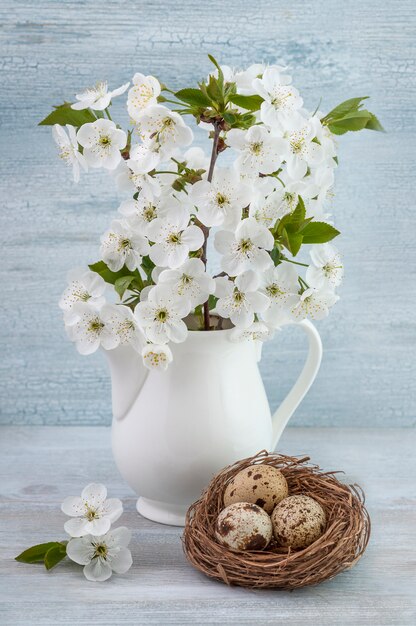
left=67, top=302, right=120, bottom=354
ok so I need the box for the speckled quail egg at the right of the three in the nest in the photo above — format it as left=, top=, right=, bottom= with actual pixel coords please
left=272, top=495, right=326, bottom=548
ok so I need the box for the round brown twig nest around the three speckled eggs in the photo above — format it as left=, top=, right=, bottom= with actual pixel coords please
left=183, top=451, right=370, bottom=589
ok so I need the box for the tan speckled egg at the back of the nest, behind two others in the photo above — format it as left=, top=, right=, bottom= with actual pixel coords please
left=224, top=465, right=288, bottom=513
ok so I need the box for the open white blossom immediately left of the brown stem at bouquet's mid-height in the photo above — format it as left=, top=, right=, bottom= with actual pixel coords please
left=147, top=210, right=204, bottom=268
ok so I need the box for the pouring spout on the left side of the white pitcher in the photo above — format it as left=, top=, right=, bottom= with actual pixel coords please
left=105, top=345, right=149, bottom=420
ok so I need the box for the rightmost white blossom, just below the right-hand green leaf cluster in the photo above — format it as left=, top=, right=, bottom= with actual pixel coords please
left=306, top=243, right=344, bottom=290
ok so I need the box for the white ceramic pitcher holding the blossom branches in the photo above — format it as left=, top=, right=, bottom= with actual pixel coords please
left=106, top=320, right=322, bottom=526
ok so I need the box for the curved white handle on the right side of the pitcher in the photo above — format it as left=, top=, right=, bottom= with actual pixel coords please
left=272, top=320, right=322, bottom=450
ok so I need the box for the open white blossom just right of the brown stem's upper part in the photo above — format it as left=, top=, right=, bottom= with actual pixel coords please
left=227, top=126, right=287, bottom=174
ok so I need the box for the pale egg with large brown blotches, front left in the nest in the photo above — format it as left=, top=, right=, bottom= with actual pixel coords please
left=215, top=502, right=273, bottom=551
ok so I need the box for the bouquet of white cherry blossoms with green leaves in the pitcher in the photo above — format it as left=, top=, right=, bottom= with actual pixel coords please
left=41, top=56, right=383, bottom=369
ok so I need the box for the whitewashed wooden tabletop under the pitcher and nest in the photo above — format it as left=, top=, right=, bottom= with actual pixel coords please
left=0, top=427, right=416, bottom=626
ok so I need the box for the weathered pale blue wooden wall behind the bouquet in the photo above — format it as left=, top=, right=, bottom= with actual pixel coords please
left=0, top=0, right=416, bottom=426
